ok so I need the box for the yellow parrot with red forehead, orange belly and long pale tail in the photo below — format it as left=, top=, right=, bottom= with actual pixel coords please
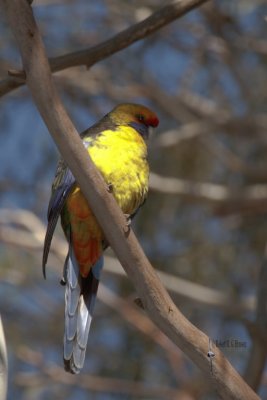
left=42, top=103, right=159, bottom=374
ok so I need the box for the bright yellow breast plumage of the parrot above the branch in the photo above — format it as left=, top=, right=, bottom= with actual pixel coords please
left=84, top=126, right=149, bottom=214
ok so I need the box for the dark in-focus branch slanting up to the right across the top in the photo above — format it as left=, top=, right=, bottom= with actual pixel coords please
left=0, top=0, right=207, bottom=96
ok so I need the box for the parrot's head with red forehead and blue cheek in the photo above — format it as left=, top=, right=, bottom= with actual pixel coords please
left=109, top=103, right=159, bottom=139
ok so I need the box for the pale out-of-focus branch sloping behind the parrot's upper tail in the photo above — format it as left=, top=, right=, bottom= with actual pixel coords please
left=0, top=209, right=256, bottom=315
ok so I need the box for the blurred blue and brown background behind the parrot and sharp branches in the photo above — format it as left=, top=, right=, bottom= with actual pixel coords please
left=0, top=0, right=267, bottom=400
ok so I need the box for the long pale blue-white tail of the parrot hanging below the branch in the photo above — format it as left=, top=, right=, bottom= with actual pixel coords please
left=64, top=244, right=103, bottom=374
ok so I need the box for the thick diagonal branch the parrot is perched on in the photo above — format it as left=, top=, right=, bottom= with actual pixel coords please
left=1, top=0, right=258, bottom=400
